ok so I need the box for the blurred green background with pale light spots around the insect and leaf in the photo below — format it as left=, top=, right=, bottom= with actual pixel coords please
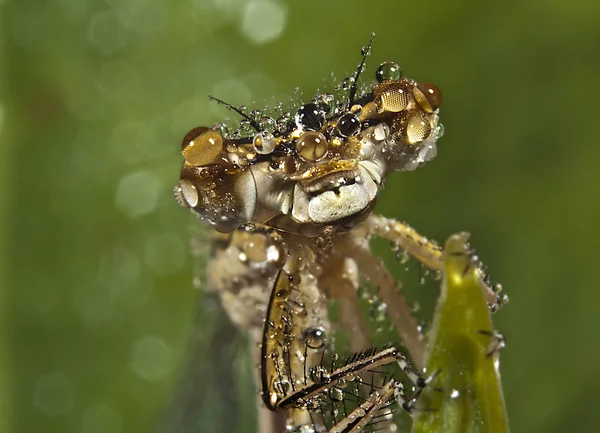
left=0, top=0, right=600, bottom=433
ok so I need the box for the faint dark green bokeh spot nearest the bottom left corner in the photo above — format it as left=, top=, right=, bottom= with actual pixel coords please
left=33, top=371, right=75, bottom=416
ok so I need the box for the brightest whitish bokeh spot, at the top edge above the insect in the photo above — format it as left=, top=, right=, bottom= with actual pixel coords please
left=242, top=0, right=287, bottom=44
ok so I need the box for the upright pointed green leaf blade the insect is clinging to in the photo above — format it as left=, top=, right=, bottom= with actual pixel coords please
left=413, top=233, right=509, bottom=433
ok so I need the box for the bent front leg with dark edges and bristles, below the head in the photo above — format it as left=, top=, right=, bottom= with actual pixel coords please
left=261, top=270, right=431, bottom=432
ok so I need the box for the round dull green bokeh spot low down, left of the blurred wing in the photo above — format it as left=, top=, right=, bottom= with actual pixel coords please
left=129, top=335, right=175, bottom=382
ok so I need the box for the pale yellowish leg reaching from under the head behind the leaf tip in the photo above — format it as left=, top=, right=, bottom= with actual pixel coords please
left=365, top=215, right=508, bottom=311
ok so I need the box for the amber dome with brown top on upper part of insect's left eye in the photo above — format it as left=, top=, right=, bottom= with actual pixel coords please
left=181, top=128, right=223, bottom=167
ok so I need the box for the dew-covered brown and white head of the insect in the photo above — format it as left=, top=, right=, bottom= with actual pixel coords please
left=175, top=62, right=441, bottom=236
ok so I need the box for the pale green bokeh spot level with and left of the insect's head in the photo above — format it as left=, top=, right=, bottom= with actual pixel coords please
left=115, top=171, right=160, bottom=218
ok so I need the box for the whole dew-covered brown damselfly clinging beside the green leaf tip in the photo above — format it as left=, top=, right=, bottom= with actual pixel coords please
left=174, top=38, right=506, bottom=433
